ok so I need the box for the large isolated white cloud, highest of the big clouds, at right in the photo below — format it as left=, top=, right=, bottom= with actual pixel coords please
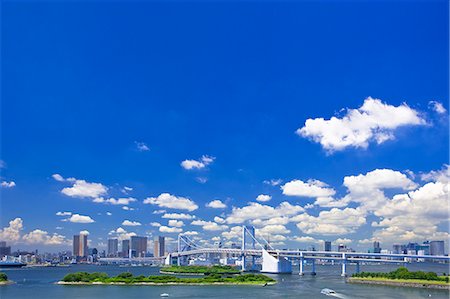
left=296, top=97, right=426, bottom=153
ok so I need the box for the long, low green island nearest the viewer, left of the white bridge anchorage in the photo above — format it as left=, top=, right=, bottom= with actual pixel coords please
left=57, top=272, right=276, bottom=285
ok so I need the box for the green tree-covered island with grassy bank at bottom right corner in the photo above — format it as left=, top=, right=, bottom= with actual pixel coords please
left=347, top=267, right=450, bottom=290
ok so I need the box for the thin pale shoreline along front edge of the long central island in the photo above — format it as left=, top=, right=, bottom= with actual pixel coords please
left=55, top=281, right=276, bottom=286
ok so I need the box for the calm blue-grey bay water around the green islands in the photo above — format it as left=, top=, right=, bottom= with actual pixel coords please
left=0, top=263, right=449, bottom=299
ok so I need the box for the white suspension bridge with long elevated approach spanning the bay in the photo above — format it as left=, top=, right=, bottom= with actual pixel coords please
left=101, top=225, right=450, bottom=276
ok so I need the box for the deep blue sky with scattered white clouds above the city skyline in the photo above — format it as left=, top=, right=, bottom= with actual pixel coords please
left=0, top=1, right=449, bottom=251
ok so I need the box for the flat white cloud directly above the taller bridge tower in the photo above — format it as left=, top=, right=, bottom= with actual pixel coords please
left=226, top=202, right=304, bottom=224
